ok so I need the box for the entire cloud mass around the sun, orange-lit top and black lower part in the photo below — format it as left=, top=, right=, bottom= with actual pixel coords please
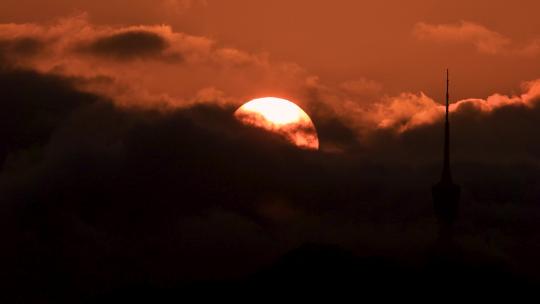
left=0, top=16, right=540, bottom=297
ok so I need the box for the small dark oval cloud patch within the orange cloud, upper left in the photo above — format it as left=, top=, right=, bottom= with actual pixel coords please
left=81, top=30, right=181, bottom=61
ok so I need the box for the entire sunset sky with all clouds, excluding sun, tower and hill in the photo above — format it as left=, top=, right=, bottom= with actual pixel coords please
left=0, top=0, right=540, bottom=298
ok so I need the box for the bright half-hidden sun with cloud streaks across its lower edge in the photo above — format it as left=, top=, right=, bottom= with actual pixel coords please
left=234, top=97, right=319, bottom=150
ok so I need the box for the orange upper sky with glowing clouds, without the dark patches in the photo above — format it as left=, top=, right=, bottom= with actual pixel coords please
left=0, top=0, right=540, bottom=134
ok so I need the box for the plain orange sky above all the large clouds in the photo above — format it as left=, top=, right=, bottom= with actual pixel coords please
left=0, top=0, right=540, bottom=98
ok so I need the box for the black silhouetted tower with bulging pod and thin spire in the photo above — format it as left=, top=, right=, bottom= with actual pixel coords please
left=432, top=70, right=461, bottom=241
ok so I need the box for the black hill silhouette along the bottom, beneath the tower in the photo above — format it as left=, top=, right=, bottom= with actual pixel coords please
left=82, top=243, right=538, bottom=303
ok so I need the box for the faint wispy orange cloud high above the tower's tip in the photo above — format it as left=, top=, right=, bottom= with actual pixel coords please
left=413, top=21, right=538, bottom=56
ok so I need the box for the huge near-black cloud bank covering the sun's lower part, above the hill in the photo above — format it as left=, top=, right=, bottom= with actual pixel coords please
left=0, top=63, right=540, bottom=298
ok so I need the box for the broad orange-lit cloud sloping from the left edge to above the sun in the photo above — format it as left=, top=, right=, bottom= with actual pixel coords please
left=0, top=14, right=308, bottom=109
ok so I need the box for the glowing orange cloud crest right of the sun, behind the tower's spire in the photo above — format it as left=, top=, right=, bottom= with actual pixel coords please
left=312, top=74, right=540, bottom=137
